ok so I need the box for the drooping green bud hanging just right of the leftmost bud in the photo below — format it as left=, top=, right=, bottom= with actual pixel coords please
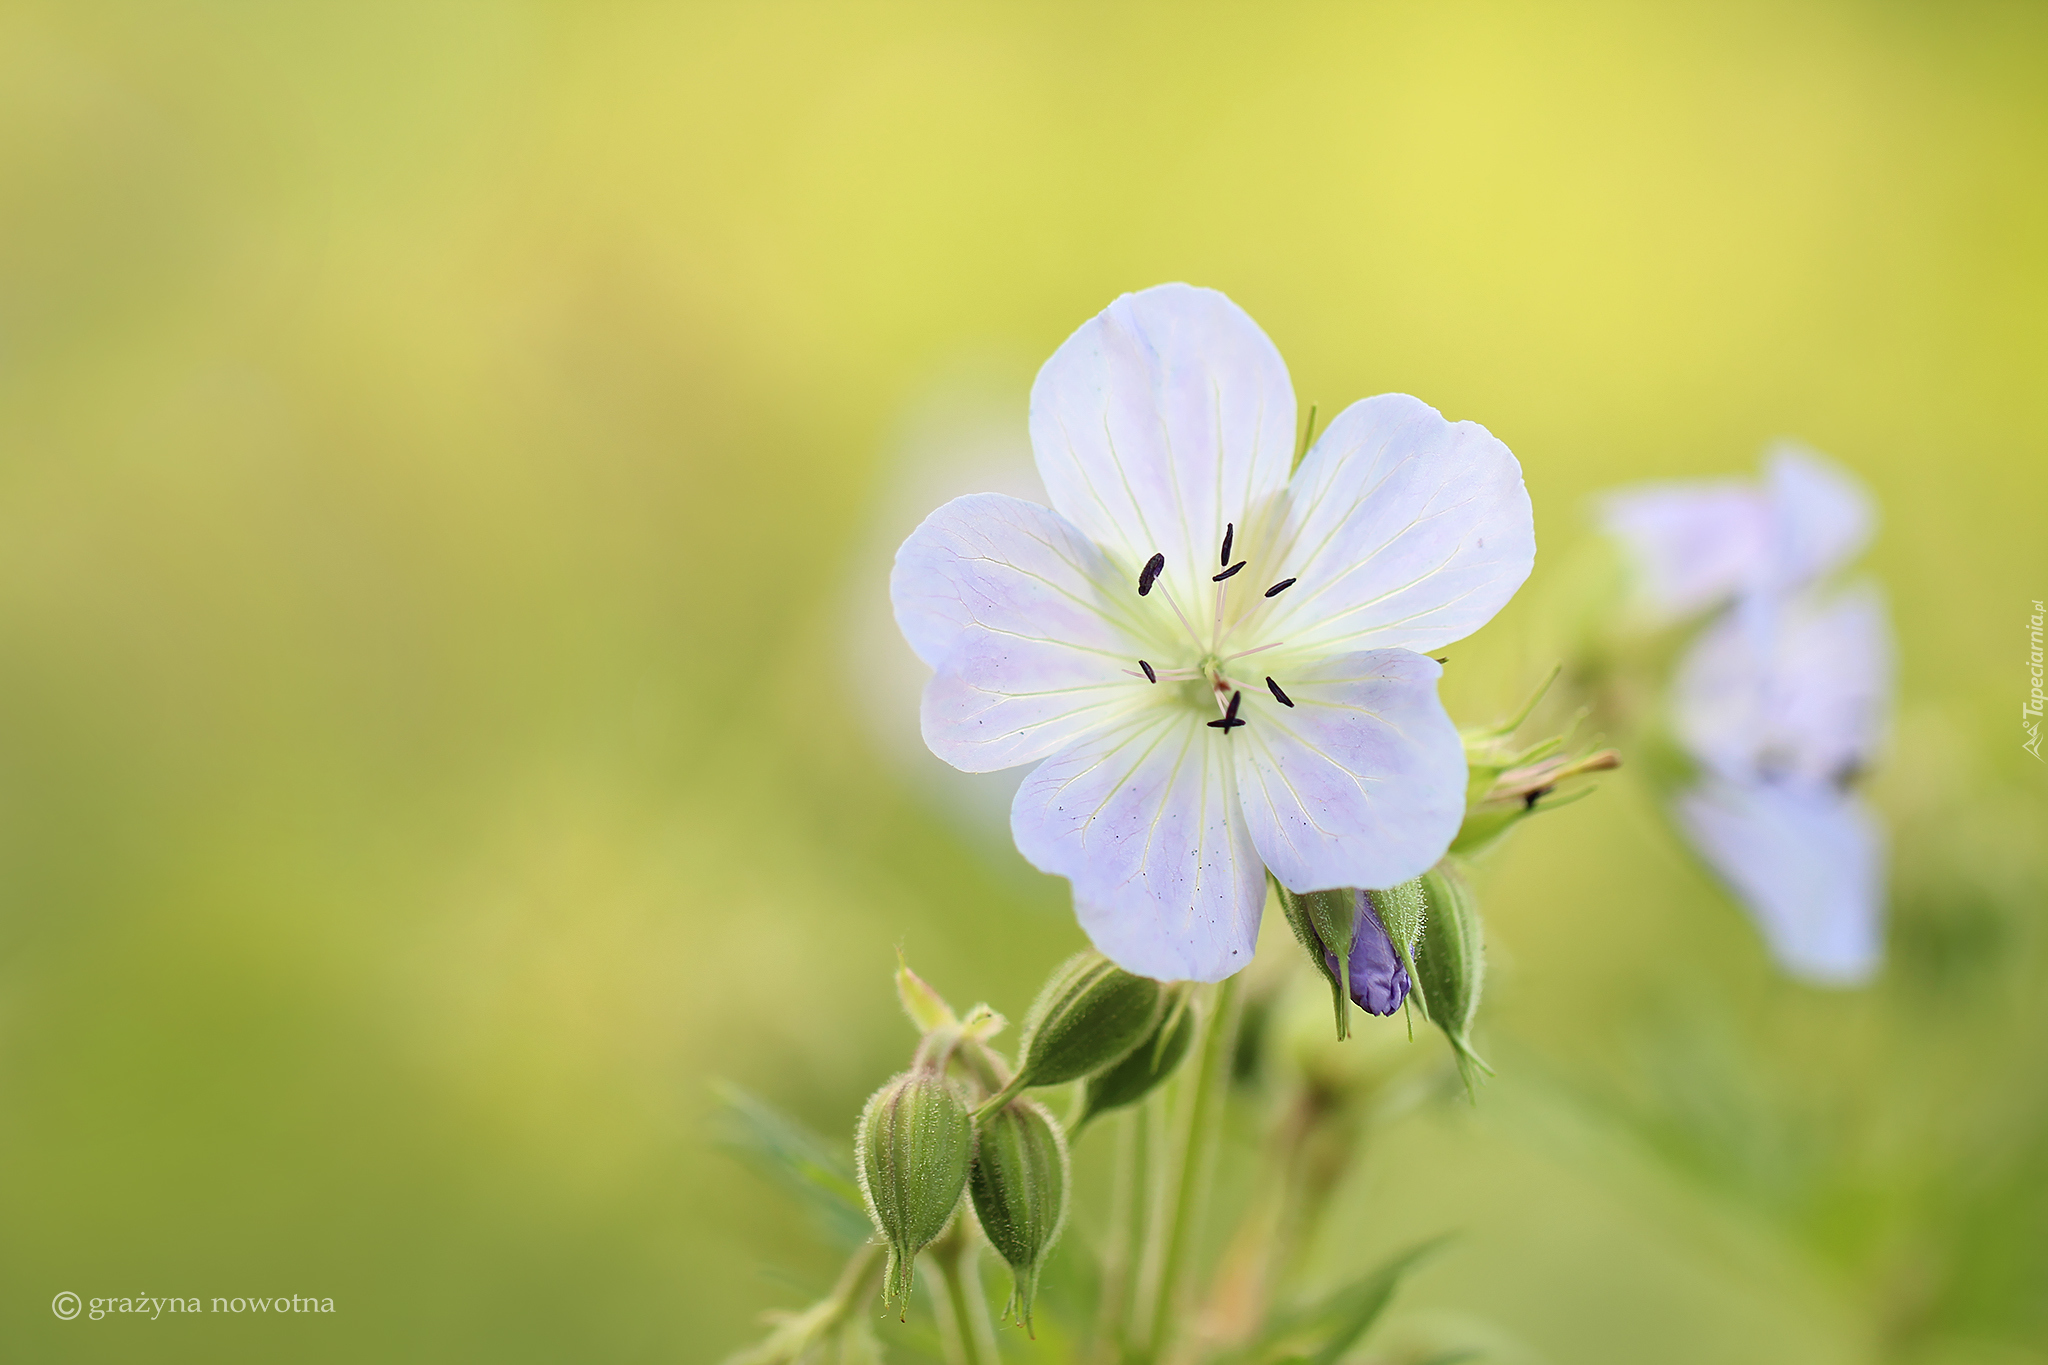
left=967, top=1099, right=1067, bottom=1336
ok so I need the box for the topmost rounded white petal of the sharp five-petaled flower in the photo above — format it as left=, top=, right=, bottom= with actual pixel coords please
left=1030, top=284, right=1294, bottom=612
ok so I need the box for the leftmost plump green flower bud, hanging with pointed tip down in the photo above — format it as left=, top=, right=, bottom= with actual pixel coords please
left=854, top=1070, right=975, bottom=1312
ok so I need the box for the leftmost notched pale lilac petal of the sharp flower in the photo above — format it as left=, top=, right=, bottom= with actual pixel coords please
left=889, top=493, right=1159, bottom=772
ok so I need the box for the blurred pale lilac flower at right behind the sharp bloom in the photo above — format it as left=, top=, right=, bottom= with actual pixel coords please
left=1606, top=446, right=1892, bottom=986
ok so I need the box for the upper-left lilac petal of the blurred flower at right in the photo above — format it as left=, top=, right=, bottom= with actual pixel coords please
left=1599, top=481, right=1765, bottom=620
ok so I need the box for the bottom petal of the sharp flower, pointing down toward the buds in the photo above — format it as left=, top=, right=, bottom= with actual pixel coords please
left=1010, top=708, right=1266, bottom=980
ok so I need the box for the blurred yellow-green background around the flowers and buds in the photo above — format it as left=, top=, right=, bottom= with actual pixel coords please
left=0, top=2, right=2048, bottom=1365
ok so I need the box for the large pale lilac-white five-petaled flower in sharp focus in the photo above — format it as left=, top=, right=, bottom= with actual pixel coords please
left=891, top=284, right=1536, bottom=980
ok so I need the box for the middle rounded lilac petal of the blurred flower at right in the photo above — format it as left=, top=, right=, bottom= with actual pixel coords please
left=1671, top=583, right=1892, bottom=786
